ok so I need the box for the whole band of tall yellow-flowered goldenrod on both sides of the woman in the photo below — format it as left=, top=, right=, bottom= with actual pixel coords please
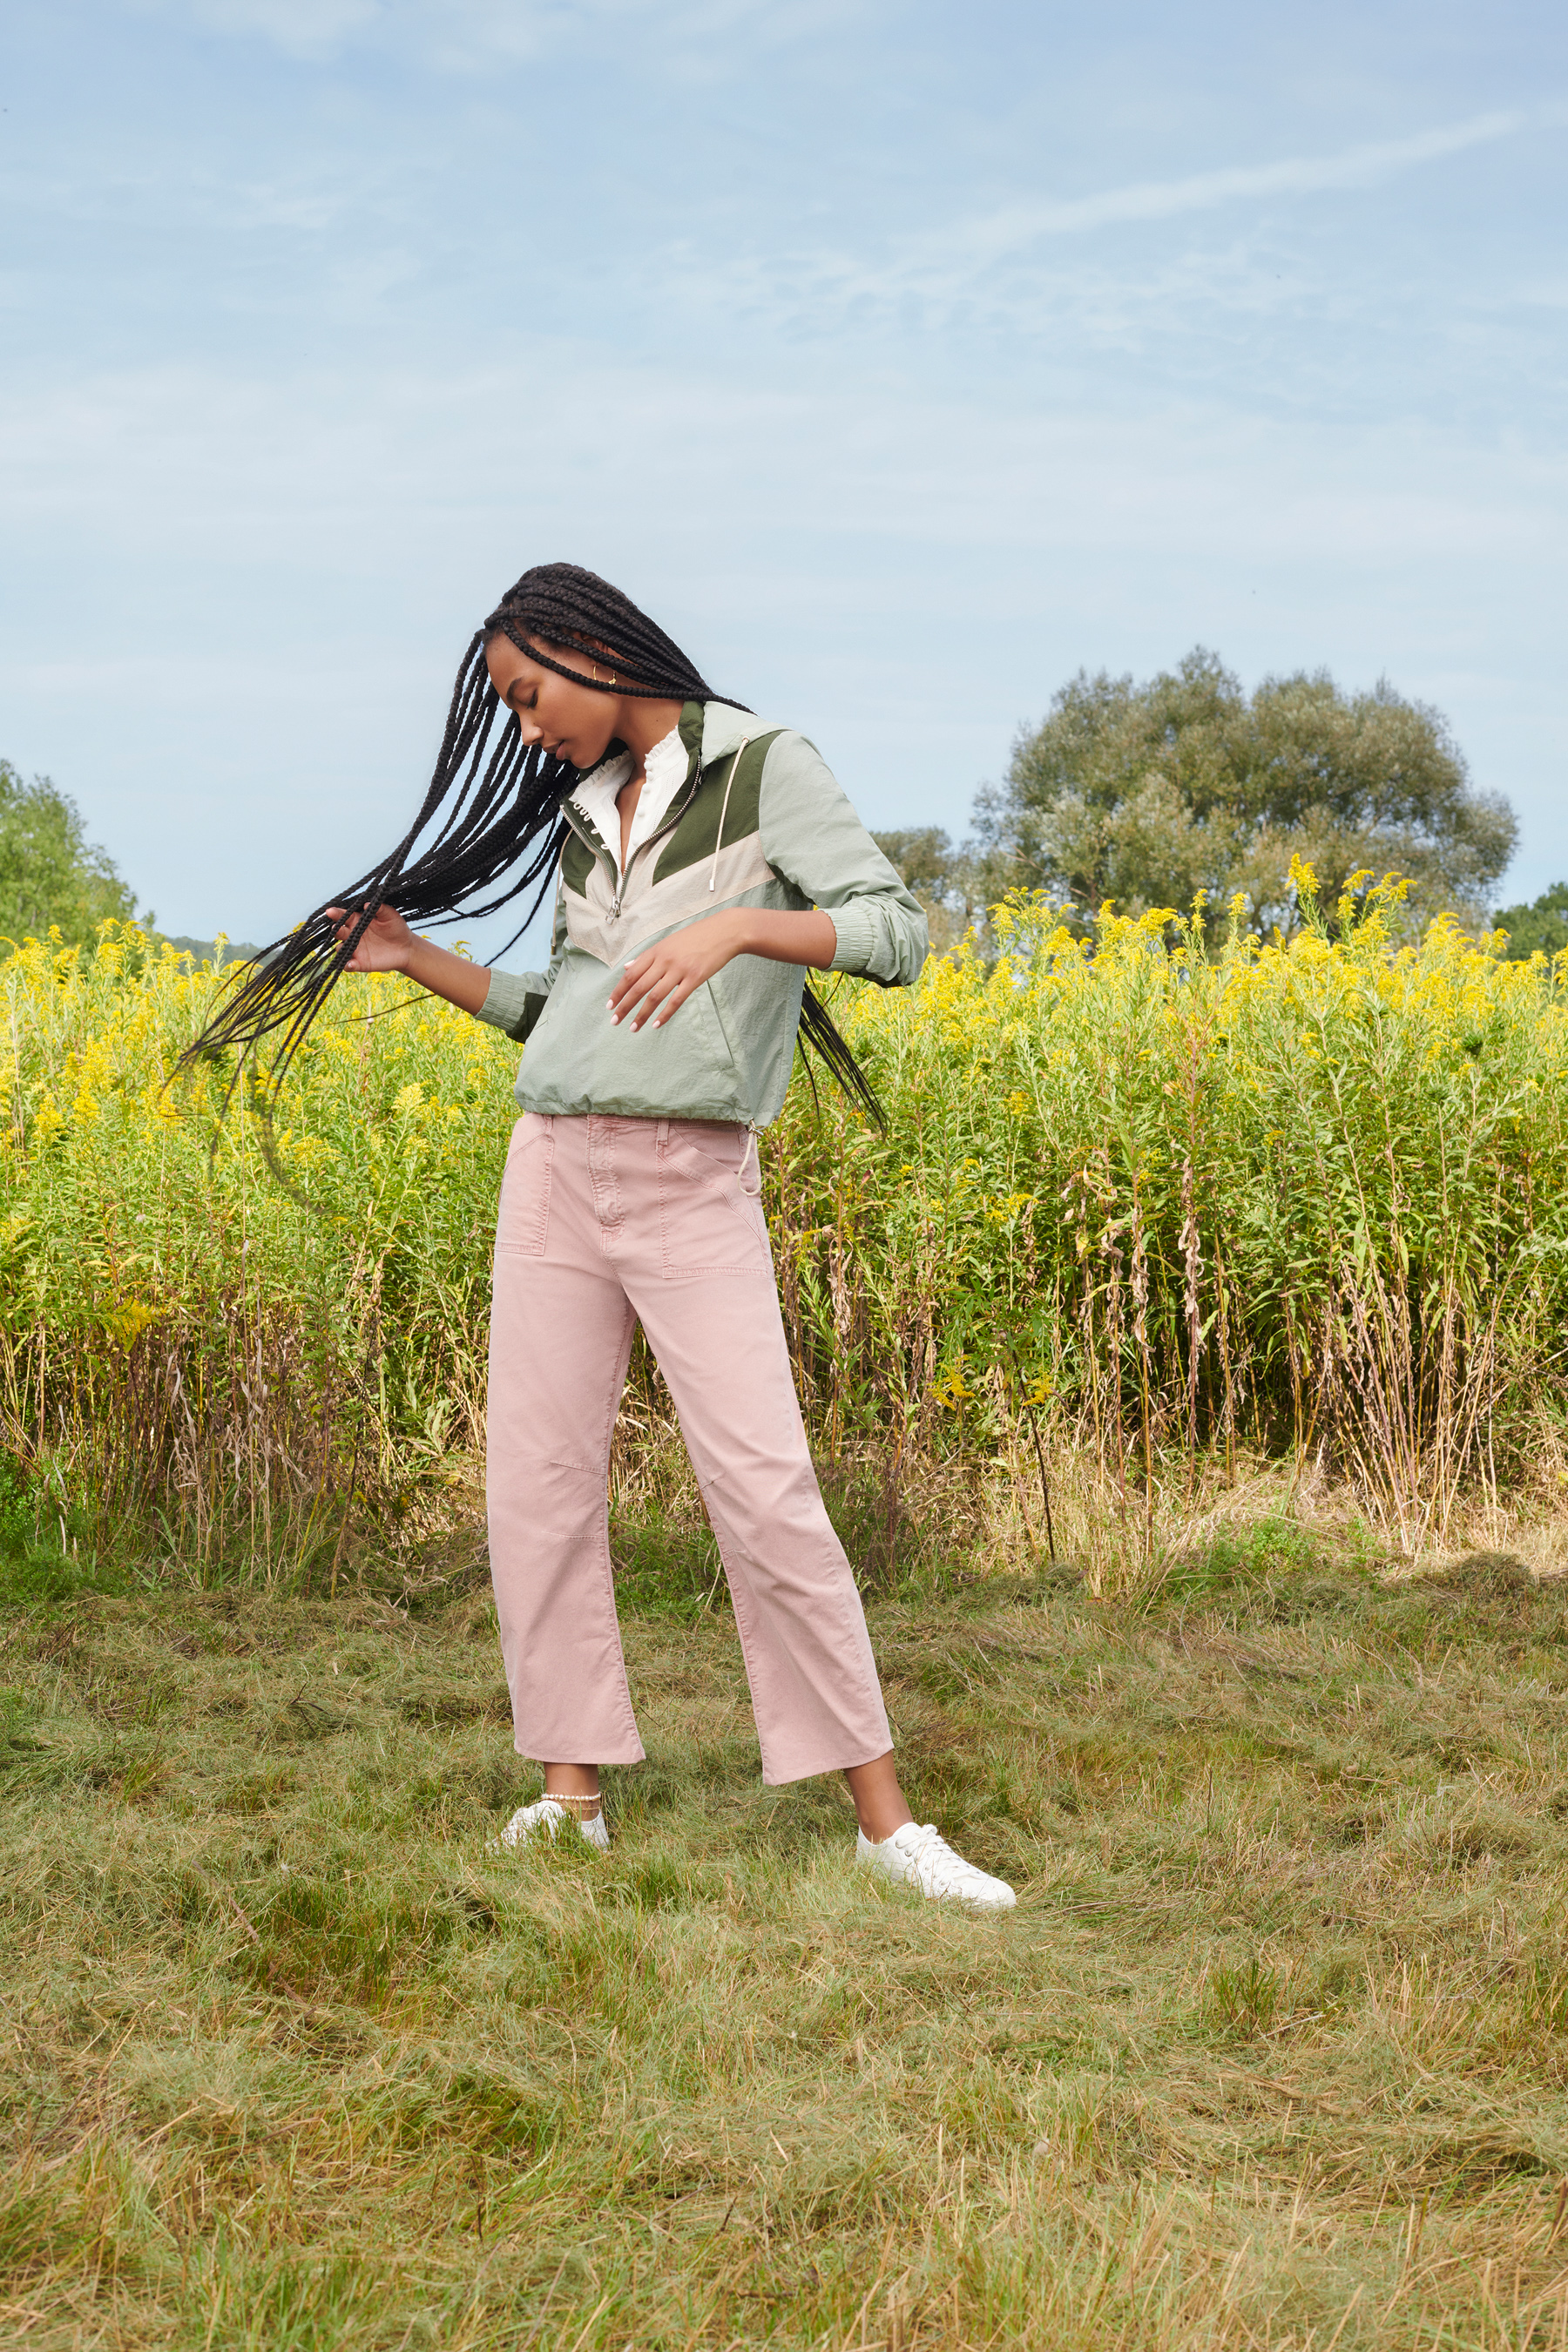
left=0, top=898, right=1568, bottom=1552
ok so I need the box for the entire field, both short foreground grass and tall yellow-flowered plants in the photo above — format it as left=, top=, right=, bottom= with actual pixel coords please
left=0, top=891, right=1568, bottom=2352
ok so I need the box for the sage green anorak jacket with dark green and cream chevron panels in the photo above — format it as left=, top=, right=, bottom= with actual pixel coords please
left=480, top=703, right=929, bottom=1126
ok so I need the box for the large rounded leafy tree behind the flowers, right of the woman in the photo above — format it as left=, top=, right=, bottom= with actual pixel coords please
left=976, top=647, right=1517, bottom=934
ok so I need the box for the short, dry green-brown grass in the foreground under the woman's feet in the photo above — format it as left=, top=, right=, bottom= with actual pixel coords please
left=0, top=1517, right=1568, bottom=2352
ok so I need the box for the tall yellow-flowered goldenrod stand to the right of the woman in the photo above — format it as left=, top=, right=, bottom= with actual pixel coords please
left=771, top=868, right=1568, bottom=1543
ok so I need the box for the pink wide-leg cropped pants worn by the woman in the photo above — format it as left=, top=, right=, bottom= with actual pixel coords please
left=487, top=1112, right=893, bottom=1785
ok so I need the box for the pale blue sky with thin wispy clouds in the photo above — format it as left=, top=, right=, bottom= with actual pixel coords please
left=0, top=0, right=1568, bottom=945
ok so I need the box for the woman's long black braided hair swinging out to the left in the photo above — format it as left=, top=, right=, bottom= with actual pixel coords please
left=183, top=564, right=884, bottom=1125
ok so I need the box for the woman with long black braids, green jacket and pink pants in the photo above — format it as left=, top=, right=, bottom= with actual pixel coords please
left=202, top=564, right=1013, bottom=1908
